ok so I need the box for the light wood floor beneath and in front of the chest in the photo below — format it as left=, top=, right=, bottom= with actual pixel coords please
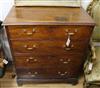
left=0, top=72, right=83, bottom=88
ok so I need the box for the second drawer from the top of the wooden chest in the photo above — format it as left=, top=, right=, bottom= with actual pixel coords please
left=11, top=40, right=87, bottom=54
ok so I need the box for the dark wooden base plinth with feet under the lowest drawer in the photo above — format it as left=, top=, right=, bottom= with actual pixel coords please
left=17, top=77, right=78, bottom=86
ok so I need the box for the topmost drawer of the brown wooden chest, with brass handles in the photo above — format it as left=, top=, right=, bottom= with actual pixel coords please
left=7, top=26, right=92, bottom=40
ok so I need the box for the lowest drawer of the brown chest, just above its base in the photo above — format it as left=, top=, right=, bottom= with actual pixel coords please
left=16, top=68, right=77, bottom=79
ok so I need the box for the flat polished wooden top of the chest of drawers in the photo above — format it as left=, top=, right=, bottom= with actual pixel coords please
left=3, top=7, right=94, bottom=25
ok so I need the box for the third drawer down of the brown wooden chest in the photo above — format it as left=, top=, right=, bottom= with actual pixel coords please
left=14, top=53, right=84, bottom=69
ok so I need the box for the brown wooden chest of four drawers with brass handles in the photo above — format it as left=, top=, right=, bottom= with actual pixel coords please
left=4, top=7, right=94, bottom=85
